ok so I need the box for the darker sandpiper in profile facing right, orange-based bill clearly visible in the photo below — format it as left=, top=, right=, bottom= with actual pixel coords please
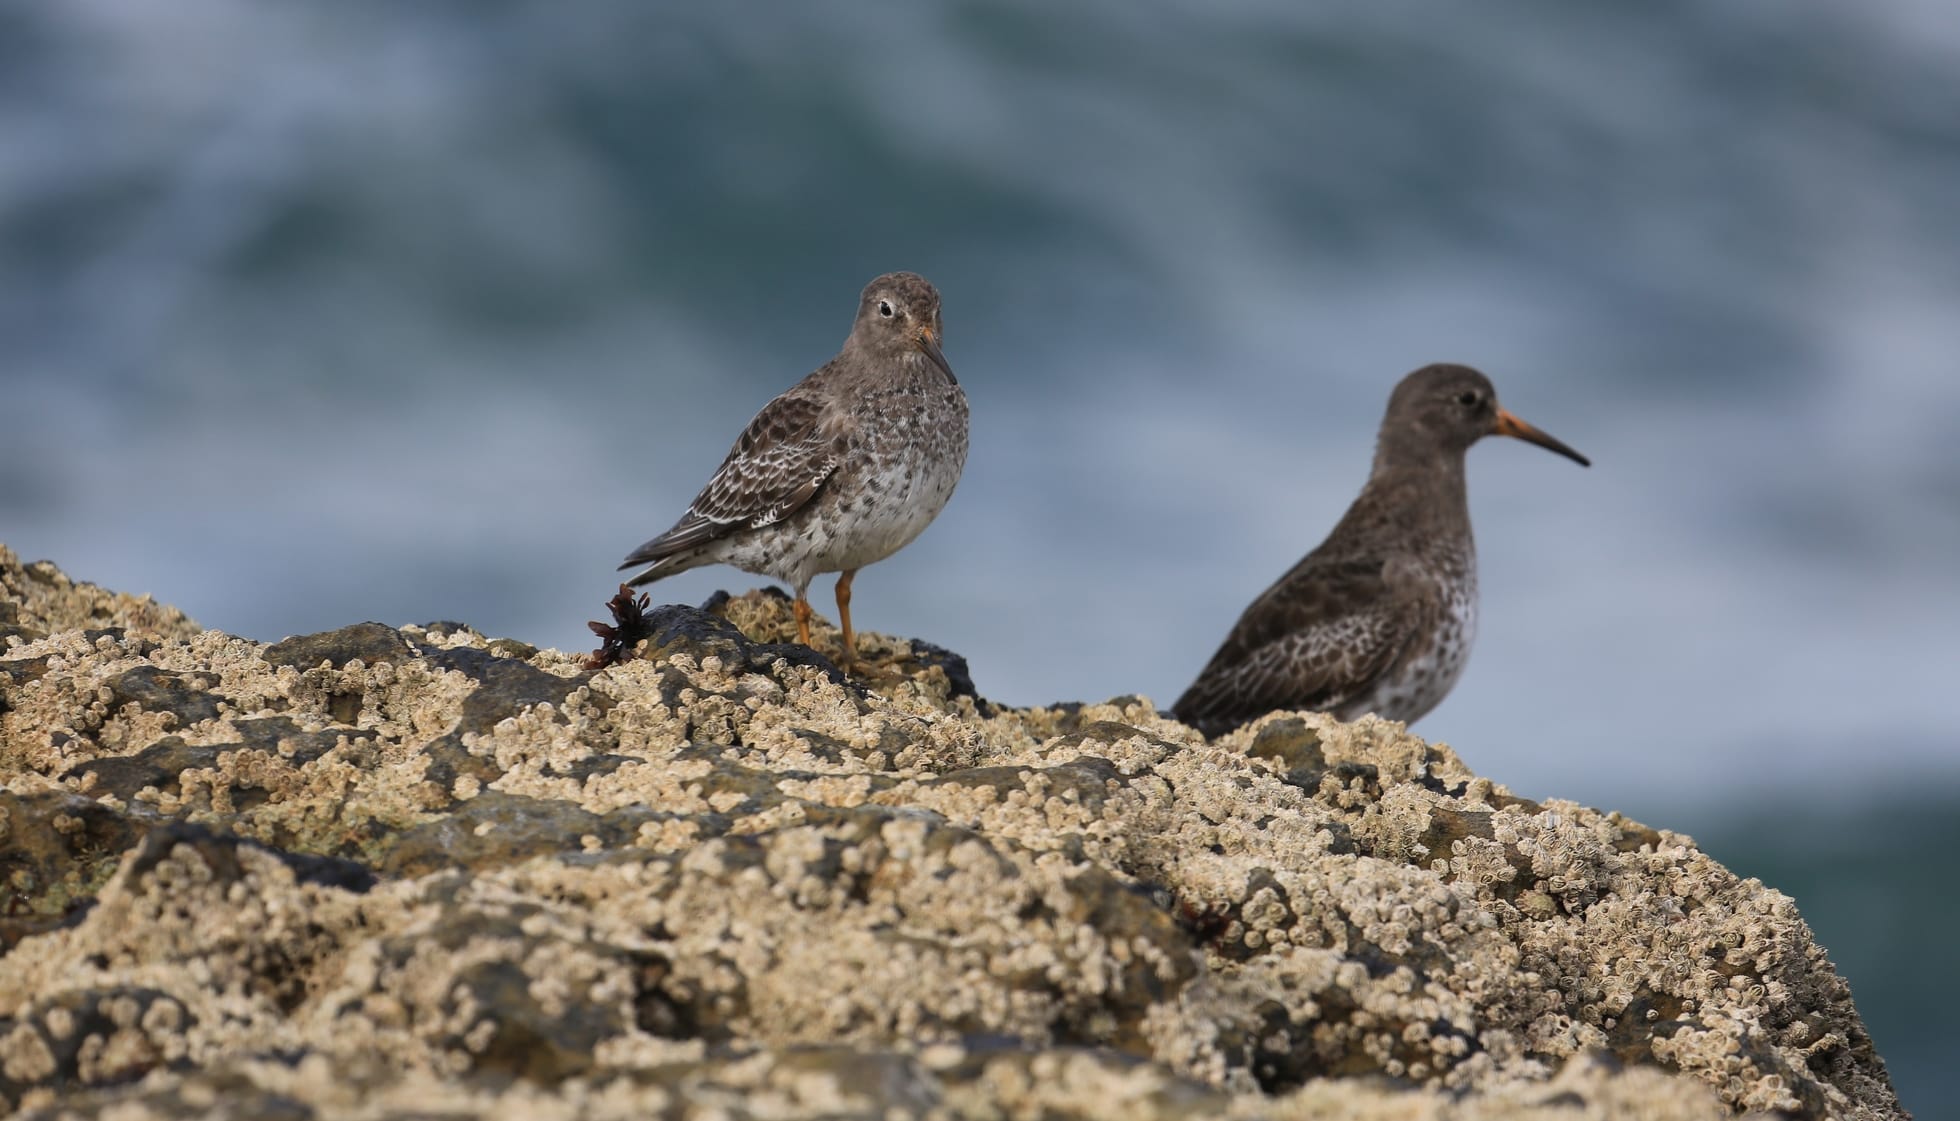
left=1172, top=365, right=1592, bottom=735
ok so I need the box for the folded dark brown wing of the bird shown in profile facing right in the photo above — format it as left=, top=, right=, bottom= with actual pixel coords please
left=1172, top=557, right=1409, bottom=733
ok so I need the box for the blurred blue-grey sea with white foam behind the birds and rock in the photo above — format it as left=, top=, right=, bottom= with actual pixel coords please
left=0, top=0, right=1960, bottom=1117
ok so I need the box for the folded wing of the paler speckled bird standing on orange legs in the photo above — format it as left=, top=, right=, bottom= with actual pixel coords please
left=619, top=390, right=839, bottom=568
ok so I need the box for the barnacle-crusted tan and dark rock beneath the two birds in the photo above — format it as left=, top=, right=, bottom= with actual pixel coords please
left=0, top=551, right=1903, bottom=1119
